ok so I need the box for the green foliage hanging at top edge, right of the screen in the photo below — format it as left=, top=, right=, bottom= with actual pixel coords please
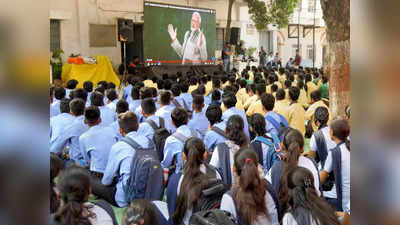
left=247, top=0, right=298, bottom=30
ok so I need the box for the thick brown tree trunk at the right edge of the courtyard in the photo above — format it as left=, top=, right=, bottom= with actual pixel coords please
left=320, top=0, right=350, bottom=117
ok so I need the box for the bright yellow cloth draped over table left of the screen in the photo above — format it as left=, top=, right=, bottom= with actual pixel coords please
left=61, top=55, right=120, bottom=88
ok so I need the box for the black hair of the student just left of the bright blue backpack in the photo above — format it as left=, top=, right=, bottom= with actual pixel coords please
left=225, top=115, right=249, bottom=147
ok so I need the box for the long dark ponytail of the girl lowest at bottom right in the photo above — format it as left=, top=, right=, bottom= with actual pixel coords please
left=286, top=167, right=340, bottom=225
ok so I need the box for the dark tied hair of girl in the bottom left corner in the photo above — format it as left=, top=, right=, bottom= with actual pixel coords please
left=54, top=166, right=96, bottom=225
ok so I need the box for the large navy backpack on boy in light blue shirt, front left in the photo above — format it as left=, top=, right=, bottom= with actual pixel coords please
left=121, top=137, right=164, bottom=203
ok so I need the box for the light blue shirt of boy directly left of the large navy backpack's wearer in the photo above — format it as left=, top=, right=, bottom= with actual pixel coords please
left=79, top=125, right=117, bottom=173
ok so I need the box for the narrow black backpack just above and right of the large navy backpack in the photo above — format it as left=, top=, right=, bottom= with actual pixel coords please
left=146, top=117, right=171, bottom=162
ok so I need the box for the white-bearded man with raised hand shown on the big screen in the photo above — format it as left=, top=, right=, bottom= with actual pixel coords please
left=168, top=12, right=207, bottom=64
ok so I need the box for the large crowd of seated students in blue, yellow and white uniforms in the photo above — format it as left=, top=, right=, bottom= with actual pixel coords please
left=50, top=67, right=350, bottom=225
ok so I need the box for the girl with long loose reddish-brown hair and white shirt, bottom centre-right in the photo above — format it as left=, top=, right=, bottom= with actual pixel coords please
left=221, top=148, right=279, bottom=225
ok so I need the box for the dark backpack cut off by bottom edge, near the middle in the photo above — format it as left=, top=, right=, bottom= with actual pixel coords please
left=189, top=209, right=236, bottom=225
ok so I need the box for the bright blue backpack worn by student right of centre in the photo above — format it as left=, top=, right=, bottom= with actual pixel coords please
left=251, top=133, right=283, bottom=173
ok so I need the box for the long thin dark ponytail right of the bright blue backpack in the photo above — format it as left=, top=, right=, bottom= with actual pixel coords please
left=278, top=129, right=304, bottom=211
